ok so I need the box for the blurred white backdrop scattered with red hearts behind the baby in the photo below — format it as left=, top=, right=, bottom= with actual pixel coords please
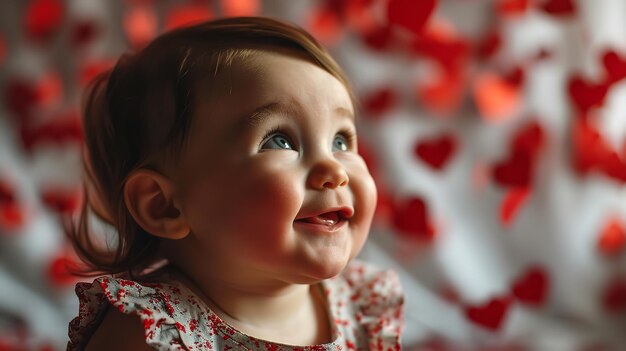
left=0, top=0, right=626, bottom=351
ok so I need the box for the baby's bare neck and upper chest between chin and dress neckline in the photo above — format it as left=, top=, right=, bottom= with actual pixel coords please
left=166, top=266, right=330, bottom=345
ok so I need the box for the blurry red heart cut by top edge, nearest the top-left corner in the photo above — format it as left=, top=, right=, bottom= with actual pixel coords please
left=24, top=0, right=64, bottom=41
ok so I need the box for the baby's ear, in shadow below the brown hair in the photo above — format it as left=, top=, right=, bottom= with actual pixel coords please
left=124, top=169, right=189, bottom=239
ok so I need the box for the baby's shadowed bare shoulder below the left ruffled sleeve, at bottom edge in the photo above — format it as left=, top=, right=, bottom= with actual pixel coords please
left=85, top=307, right=152, bottom=351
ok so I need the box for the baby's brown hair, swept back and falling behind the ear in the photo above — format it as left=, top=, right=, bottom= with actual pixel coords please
left=68, top=17, right=356, bottom=275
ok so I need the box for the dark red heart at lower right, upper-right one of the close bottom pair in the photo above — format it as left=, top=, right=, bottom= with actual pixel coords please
left=513, top=266, right=550, bottom=307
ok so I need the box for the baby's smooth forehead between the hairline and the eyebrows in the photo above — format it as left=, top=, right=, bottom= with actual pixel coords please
left=192, top=49, right=354, bottom=135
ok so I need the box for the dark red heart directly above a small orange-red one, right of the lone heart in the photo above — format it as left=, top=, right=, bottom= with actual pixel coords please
left=492, top=151, right=534, bottom=188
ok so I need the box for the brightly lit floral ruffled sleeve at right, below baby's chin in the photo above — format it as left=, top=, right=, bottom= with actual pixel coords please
left=346, top=264, right=404, bottom=351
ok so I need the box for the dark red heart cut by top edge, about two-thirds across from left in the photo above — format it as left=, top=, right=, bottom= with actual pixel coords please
left=387, top=0, right=437, bottom=34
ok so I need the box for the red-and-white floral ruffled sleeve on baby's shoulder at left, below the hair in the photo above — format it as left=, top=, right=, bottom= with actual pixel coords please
left=68, top=277, right=189, bottom=350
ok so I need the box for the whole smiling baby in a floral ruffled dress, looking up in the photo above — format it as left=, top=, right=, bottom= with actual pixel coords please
left=68, top=17, right=403, bottom=350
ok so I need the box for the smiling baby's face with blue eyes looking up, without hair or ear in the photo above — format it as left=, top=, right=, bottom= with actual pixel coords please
left=174, top=50, right=376, bottom=283
